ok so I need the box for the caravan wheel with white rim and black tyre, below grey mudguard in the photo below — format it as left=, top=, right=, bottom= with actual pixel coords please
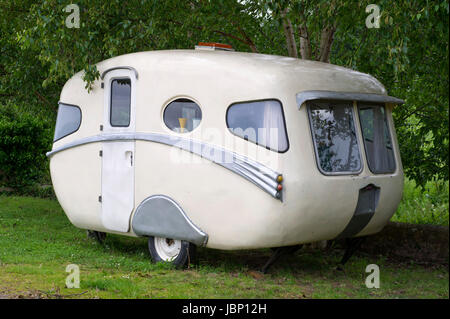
left=148, top=236, right=196, bottom=268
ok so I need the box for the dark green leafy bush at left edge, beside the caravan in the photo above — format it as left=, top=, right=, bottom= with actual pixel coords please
left=0, top=105, right=52, bottom=189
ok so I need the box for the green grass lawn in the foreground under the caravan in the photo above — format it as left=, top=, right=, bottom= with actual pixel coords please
left=0, top=196, right=449, bottom=298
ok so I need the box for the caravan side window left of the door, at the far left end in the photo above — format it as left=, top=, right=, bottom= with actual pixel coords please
left=53, top=103, right=81, bottom=142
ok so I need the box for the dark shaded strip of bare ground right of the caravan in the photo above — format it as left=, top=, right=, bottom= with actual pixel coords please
left=340, top=222, right=449, bottom=264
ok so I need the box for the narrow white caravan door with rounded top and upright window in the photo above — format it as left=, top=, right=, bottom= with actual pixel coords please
left=101, top=69, right=136, bottom=232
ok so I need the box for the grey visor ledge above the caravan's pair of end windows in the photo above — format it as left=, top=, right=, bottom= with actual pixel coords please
left=296, top=90, right=405, bottom=109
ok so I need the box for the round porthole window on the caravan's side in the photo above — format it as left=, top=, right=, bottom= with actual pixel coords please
left=163, top=99, right=202, bottom=133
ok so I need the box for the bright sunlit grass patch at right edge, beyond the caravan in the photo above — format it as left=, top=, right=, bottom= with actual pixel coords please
left=391, top=179, right=449, bottom=226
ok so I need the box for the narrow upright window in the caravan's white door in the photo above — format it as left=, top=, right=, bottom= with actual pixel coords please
left=109, top=79, right=131, bottom=127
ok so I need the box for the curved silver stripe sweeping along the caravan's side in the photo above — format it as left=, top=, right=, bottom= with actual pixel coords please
left=47, top=133, right=281, bottom=199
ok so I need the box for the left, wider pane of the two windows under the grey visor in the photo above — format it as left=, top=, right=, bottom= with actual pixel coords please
left=308, top=101, right=362, bottom=174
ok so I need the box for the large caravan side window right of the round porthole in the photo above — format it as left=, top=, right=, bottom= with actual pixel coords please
left=226, top=100, right=289, bottom=153
